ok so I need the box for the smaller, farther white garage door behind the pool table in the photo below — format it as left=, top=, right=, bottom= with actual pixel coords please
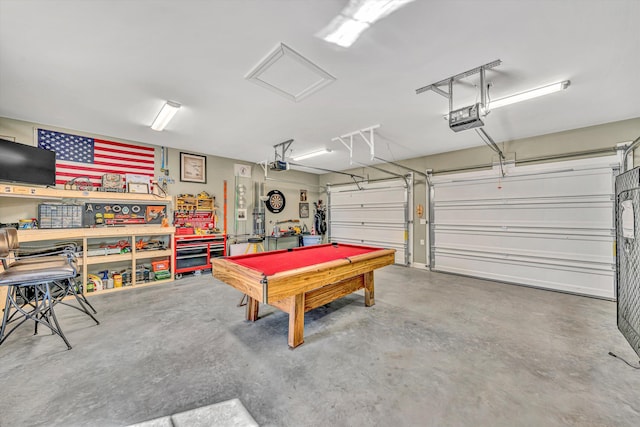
left=327, top=177, right=411, bottom=265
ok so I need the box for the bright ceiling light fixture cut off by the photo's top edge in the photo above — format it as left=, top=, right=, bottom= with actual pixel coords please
left=316, top=0, right=413, bottom=47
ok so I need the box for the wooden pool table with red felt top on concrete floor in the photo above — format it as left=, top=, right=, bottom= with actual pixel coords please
left=211, top=243, right=395, bottom=348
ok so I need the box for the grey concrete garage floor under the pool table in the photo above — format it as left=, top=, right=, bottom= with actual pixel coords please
left=0, top=266, right=640, bottom=427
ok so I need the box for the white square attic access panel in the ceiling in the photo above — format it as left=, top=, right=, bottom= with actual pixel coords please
left=245, top=43, right=336, bottom=102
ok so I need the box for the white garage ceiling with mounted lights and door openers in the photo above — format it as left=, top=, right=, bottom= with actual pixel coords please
left=0, top=0, right=640, bottom=172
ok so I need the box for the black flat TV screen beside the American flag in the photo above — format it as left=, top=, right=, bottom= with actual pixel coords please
left=0, top=139, right=56, bottom=185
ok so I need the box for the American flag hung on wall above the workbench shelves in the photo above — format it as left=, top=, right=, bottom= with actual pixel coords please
left=38, top=129, right=155, bottom=187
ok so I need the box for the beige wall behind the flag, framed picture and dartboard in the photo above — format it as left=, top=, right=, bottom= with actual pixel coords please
left=0, top=117, right=319, bottom=234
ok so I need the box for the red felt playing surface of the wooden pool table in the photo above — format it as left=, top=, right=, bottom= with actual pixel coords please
left=227, top=244, right=384, bottom=276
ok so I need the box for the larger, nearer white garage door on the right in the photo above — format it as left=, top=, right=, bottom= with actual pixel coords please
left=431, top=156, right=619, bottom=299
